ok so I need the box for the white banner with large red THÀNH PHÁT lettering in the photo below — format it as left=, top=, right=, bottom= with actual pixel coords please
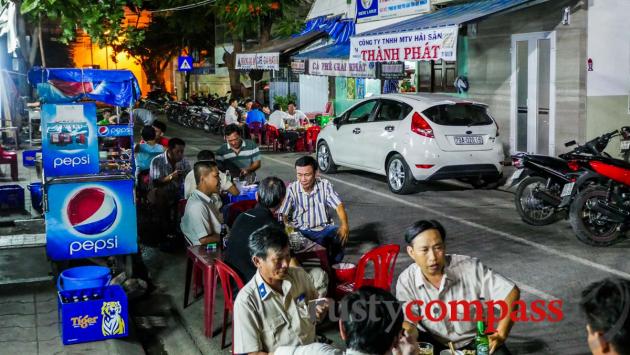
left=350, top=26, right=458, bottom=63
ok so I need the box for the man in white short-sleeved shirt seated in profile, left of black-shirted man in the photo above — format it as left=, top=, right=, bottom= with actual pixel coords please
left=180, top=160, right=222, bottom=245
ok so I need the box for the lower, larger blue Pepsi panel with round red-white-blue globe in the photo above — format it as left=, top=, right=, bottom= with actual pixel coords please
left=46, top=179, right=138, bottom=260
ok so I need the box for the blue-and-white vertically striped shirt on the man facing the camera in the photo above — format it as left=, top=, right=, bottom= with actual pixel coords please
left=278, top=178, right=341, bottom=229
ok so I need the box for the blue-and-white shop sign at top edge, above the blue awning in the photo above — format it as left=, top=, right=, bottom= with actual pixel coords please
left=357, top=0, right=431, bottom=22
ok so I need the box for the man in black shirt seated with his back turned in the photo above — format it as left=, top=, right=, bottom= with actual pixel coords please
left=223, top=176, right=328, bottom=297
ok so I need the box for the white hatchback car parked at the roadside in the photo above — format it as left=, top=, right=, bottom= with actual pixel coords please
left=317, top=94, right=504, bottom=194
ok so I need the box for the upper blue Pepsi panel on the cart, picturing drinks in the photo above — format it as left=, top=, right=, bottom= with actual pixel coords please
left=41, top=103, right=99, bottom=177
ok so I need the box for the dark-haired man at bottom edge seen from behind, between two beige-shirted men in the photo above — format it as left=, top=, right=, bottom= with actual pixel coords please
left=274, top=286, right=418, bottom=355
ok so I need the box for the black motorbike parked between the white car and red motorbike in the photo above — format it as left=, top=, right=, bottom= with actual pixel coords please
left=508, top=130, right=619, bottom=226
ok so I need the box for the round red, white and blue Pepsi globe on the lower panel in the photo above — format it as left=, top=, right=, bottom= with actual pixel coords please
left=66, top=187, right=118, bottom=235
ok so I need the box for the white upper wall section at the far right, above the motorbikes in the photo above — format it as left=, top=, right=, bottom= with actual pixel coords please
left=583, top=0, right=630, bottom=96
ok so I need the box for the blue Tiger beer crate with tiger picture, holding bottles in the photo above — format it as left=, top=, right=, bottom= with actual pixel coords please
left=57, top=285, right=129, bottom=345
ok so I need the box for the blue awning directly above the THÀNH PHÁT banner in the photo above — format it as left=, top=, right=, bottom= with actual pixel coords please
left=354, top=0, right=548, bottom=37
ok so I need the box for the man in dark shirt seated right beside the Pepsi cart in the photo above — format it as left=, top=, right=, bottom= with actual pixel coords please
left=148, top=138, right=190, bottom=248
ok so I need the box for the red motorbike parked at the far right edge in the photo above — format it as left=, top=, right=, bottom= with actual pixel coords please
left=564, top=155, right=630, bottom=246
